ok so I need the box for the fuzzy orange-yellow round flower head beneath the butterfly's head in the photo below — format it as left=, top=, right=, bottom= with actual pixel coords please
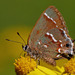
left=14, top=56, right=36, bottom=75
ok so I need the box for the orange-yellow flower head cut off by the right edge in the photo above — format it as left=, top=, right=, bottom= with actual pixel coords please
left=65, top=58, right=75, bottom=74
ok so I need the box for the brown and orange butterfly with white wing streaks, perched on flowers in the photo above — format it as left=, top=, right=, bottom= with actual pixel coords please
left=6, top=6, right=75, bottom=65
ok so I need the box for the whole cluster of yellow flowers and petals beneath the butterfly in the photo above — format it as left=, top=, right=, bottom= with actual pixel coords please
left=14, top=56, right=75, bottom=75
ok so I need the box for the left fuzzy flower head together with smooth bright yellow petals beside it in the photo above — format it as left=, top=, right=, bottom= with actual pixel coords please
left=14, top=56, right=57, bottom=75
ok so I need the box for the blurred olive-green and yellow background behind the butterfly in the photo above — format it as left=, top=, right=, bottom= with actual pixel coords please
left=0, top=0, right=75, bottom=75
